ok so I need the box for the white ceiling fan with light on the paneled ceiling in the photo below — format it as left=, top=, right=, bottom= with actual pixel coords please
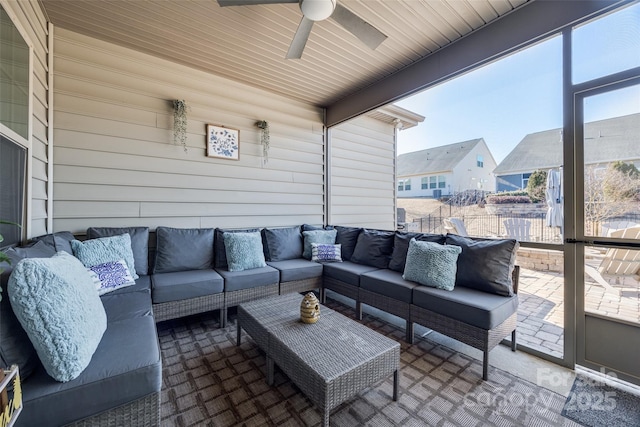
left=218, top=0, right=387, bottom=59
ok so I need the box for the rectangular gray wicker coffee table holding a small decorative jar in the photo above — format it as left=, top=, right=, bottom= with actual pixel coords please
left=237, top=294, right=400, bottom=426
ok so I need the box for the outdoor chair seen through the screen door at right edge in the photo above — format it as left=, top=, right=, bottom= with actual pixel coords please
left=584, top=226, right=640, bottom=295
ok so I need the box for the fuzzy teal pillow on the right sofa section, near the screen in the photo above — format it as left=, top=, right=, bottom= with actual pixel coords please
left=402, top=239, right=462, bottom=291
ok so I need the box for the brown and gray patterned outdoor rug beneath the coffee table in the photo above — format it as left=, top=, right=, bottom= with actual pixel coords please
left=158, top=300, right=580, bottom=427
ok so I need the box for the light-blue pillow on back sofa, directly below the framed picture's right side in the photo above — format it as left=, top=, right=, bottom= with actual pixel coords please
left=224, top=231, right=267, bottom=271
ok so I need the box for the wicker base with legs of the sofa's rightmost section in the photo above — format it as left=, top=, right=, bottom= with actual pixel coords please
left=409, top=304, right=518, bottom=380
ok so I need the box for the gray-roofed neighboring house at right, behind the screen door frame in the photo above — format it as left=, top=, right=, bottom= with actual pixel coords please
left=493, top=114, right=640, bottom=191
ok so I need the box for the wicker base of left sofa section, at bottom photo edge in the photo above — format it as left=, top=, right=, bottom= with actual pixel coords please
left=67, top=392, right=160, bottom=427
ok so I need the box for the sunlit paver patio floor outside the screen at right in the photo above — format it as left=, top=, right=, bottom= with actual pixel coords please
left=517, top=256, right=640, bottom=357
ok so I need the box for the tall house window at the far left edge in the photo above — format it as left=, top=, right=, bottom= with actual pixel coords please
left=0, top=6, right=31, bottom=248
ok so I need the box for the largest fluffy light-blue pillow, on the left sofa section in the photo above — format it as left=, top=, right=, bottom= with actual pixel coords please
left=8, top=251, right=107, bottom=382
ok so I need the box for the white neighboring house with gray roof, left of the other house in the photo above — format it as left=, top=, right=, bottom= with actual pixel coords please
left=397, top=138, right=496, bottom=197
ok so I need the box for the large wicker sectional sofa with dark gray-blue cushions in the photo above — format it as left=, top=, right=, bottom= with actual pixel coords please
left=0, top=225, right=518, bottom=426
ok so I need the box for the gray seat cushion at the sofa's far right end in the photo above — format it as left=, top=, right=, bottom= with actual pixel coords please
left=413, top=286, right=518, bottom=330
